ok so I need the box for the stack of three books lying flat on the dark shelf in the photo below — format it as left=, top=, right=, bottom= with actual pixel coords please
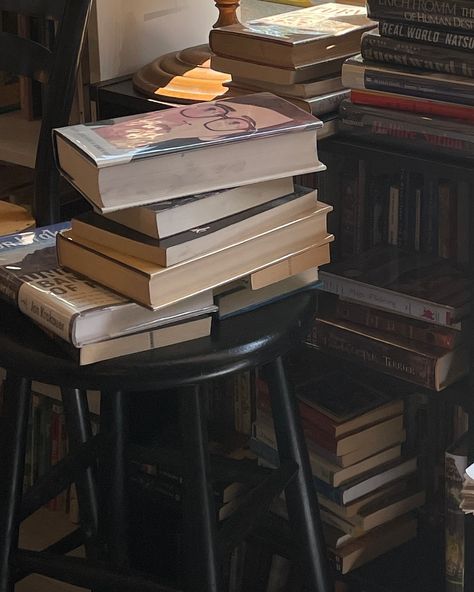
left=308, top=246, right=470, bottom=391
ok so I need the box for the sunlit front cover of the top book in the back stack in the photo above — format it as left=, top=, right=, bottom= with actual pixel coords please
left=225, top=2, right=375, bottom=44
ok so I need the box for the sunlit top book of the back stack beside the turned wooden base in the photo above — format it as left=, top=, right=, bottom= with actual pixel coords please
left=209, top=2, right=376, bottom=68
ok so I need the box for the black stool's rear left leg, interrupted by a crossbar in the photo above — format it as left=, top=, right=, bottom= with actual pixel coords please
left=61, top=388, right=99, bottom=559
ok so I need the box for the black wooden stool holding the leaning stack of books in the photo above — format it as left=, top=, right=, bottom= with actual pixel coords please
left=0, top=293, right=332, bottom=592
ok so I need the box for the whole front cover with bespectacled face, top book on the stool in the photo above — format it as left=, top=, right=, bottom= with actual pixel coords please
left=56, top=93, right=322, bottom=168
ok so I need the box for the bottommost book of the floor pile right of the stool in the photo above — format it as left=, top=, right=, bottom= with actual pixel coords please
left=325, top=515, right=417, bottom=574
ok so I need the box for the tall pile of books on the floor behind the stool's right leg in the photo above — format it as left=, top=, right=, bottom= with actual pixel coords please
left=250, top=372, right=425, bottom=573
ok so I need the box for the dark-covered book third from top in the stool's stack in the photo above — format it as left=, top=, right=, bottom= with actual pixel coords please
left=71, top=187, right=325, bottom=267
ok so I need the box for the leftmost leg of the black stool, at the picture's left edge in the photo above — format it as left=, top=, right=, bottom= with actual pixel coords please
left=0, top=373, right=31, bottom=592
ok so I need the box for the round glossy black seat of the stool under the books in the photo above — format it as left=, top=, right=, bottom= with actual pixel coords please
left=0, top=292, right=315, bottom=391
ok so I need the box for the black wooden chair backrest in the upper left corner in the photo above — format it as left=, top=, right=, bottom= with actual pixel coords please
left=0, top=0, right=92, bottom=226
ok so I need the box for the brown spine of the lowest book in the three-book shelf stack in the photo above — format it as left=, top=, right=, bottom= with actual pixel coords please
left=311, top=319, right=436, bottom=389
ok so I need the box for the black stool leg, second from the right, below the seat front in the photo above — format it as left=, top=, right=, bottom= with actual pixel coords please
left=180, top=386, right=223, bottom=592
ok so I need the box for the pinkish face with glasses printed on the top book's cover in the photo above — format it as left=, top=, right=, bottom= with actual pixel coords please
left=95, top=101, right=290, bottom=150
